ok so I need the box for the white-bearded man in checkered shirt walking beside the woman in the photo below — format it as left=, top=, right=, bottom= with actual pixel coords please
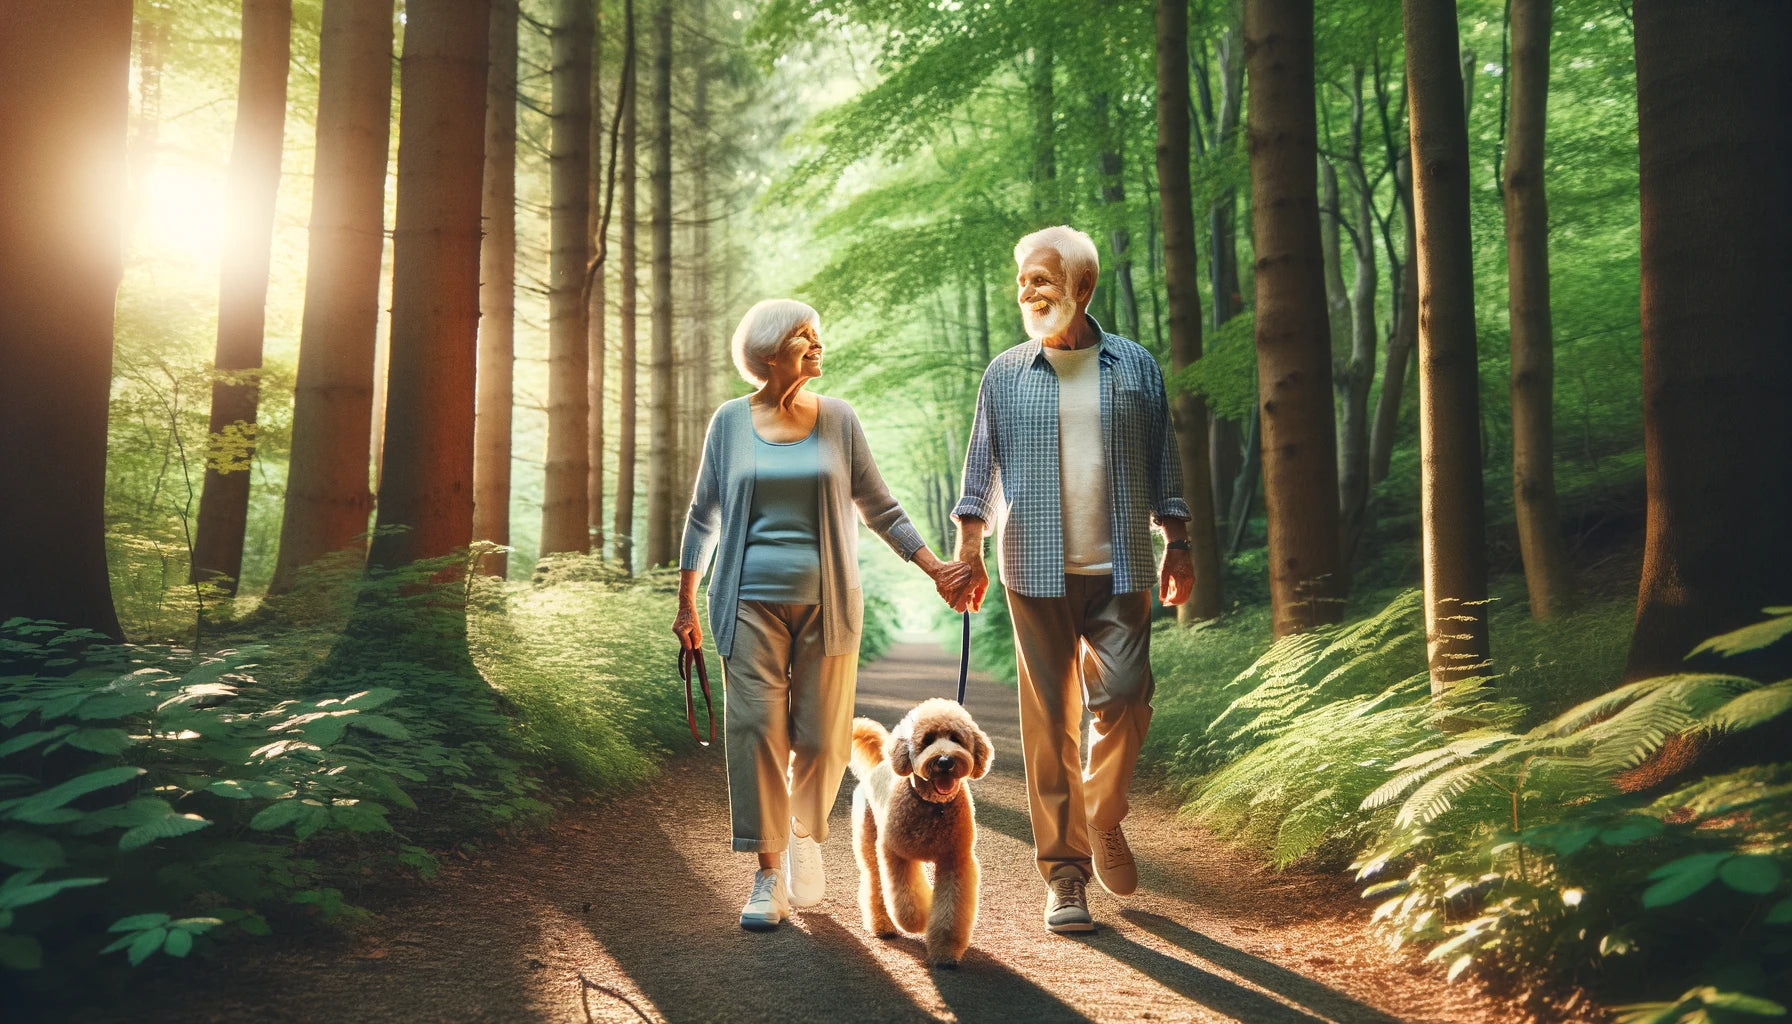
left=952, top=226, right=1193, bottom=933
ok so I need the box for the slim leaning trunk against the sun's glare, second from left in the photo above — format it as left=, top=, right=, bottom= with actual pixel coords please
left=192, top=0, right=292, bottom=594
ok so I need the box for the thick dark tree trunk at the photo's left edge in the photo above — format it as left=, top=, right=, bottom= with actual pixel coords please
left=0, top=0, right=131, bottom=638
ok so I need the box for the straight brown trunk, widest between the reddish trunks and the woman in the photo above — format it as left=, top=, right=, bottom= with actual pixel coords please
left=541, top=0, right=593, bottom=554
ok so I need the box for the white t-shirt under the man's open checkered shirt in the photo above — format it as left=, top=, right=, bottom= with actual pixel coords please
left=1045, top=344, right=1115, bottom=576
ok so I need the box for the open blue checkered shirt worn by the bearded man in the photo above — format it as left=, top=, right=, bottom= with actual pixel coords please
left=952, top=317, right=1188, bottom=597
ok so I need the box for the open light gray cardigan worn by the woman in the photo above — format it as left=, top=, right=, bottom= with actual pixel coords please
left=679, top=396, right=923, bottom=658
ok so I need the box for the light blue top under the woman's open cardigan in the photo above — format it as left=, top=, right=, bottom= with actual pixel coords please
left=740, top=430, right=821, bottom=604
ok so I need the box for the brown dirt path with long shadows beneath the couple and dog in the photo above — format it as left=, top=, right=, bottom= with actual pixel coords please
left=24, top=644, right=1600, bottom=1024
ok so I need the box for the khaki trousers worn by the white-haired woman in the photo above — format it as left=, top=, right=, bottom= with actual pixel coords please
left=722, top=601, right=858, bottom=854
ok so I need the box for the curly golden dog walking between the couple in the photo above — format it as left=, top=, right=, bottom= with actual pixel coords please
left=853, top=698, right=995, bottom=967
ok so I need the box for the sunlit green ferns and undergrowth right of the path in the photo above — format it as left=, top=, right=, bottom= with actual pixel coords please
left=1167, top=594, right=1792, bottom=1022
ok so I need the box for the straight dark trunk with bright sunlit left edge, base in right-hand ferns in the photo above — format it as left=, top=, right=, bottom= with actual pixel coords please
left=1405, top=0, right=1487, bottom=694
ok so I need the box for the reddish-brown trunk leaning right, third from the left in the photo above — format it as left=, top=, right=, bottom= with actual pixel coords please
left=269, top=0, right=397, bottom=594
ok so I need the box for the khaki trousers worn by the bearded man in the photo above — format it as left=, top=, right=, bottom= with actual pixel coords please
left=1007, top=574, right=1154, bottom=881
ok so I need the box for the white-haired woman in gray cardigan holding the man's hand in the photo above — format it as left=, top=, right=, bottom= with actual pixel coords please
left=672, top=299, right=969, bottom=931
